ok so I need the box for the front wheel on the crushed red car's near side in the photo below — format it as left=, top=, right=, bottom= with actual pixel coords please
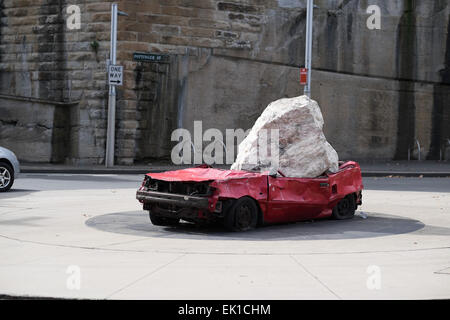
left=224, top=197, right=258, bottom=231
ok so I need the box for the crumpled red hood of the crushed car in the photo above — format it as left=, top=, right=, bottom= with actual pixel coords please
left=147, top=168, right=266, bottom=182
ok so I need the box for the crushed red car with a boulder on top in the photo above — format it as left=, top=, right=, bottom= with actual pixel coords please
left=136, top=161, right=363, bottom=231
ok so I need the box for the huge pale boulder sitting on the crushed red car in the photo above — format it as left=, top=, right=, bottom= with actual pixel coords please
left=231, top=96, right=339, bottom=178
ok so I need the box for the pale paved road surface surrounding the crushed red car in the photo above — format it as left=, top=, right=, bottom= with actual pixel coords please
left=0, top=174, right=450, bottom=299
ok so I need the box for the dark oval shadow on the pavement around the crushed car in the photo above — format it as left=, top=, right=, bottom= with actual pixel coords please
left=86, top=211, right=450, bottom=241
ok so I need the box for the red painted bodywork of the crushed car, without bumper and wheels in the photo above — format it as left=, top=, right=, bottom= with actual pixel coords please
left=142, top=161, right=363, bottom=223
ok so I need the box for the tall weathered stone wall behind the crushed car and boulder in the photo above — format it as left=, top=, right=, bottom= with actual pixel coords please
left=0, top=0, right=450, bottom=164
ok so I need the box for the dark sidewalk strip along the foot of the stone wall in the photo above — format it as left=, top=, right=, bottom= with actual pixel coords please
left=21, top=160, right=450, bottom=177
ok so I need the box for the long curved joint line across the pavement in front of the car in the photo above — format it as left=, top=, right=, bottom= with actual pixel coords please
left=0, top=234, right=450, bottom=256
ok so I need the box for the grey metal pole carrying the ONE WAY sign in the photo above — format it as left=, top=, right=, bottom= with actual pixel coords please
left=105, top=3, right=117, bottom=167
